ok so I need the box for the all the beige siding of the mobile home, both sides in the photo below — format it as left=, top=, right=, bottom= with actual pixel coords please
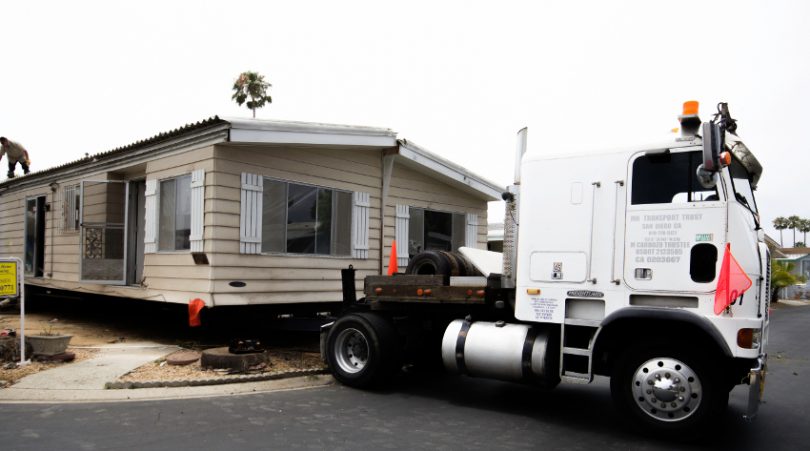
left=0, top=139, right=487, bottom=306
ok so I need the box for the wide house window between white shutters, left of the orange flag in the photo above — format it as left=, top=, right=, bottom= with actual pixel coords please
left=262, top=178, right=352, bottom=255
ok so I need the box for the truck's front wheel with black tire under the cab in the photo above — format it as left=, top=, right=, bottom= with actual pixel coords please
left=610, top=345, right=728, bottom=439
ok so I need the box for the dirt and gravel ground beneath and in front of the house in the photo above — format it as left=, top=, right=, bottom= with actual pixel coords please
left=0, top=298, right=323, bottom=388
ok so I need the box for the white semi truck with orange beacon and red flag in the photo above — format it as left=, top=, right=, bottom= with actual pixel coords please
left=322, top=102, right=770, bottom=431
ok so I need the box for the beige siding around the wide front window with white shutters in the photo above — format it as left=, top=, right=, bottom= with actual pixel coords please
left=206, top=145, right=382, bottom=305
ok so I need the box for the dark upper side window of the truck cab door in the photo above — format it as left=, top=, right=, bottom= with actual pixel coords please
left=631, top=152, right=718, bottom=205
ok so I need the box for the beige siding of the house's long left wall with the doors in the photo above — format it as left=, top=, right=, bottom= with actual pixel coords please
left=0, top=146, right=216, bottom=305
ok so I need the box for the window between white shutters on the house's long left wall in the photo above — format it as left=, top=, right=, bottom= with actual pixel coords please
left=158, top=175, right=191, bottom=251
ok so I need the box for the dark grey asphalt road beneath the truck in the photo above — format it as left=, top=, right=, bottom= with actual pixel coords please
left=0, top=306, right=810, bottom=451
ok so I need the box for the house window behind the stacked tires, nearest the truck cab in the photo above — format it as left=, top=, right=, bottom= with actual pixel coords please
left=408, top=208, right=466, bottom=256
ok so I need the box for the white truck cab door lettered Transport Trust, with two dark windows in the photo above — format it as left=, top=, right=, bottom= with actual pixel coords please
left=624, top=148, right=726, bottom=293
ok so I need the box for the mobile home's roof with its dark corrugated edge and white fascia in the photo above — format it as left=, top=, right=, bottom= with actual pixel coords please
left=0, top=116, right=503, bottom=200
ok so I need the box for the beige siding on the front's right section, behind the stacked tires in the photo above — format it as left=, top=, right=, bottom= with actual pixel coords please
left=383, top=163, right=487, bottom=273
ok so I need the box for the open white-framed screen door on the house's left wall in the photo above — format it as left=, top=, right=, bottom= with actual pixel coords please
left=80, top=181, right=128, bottom=285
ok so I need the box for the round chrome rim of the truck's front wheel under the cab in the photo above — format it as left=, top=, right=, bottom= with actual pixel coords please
left=631, top=357, right=703, bottom=422
